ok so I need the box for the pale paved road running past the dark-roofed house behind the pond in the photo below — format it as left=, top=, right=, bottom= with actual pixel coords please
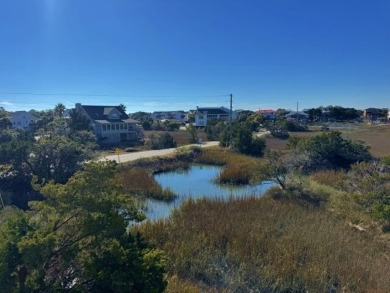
left=99, top=141, right=219, bottom=163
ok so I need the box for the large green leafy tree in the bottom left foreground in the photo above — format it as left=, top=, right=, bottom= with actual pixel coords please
left=0, top=161, right=166, bottom=292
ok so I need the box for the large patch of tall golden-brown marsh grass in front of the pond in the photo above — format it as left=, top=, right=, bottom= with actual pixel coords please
left=139, top=196, right=390, bottom=293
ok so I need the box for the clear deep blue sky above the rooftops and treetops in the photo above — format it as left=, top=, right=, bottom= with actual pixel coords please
left=0, top=0, right=390, bottom=112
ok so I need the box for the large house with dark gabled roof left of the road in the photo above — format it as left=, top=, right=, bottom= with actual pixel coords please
left=76, top=103, right=144, bottom=144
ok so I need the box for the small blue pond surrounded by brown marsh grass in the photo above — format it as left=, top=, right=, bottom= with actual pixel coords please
left=146, top=165, right=273, bottom=220
